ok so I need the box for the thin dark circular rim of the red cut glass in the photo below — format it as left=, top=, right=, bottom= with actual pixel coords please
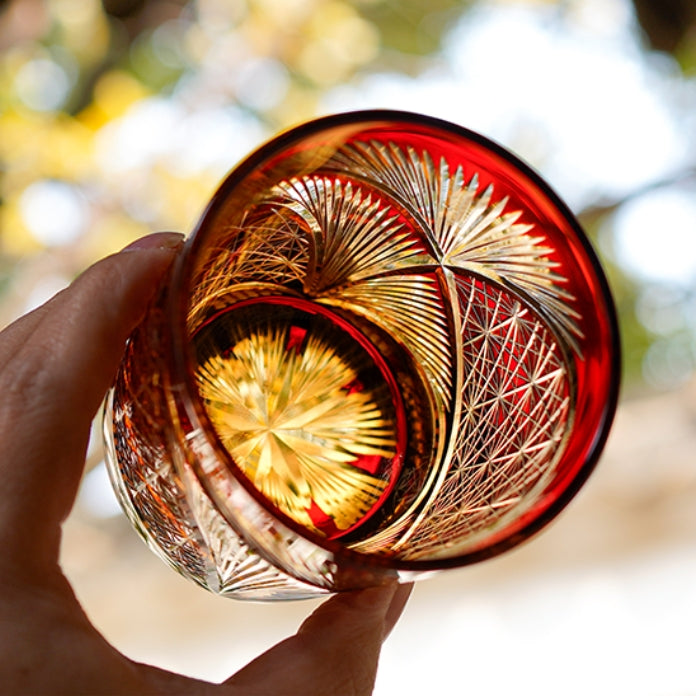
left=164, top=109, right=621, bottom=573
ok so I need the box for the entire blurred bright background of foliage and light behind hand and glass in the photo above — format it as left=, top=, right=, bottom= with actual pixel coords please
left=0, top=0, right=696, bottom=696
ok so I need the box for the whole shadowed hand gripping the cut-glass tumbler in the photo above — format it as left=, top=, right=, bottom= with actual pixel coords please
left=0, top=233, right=410, bottom=696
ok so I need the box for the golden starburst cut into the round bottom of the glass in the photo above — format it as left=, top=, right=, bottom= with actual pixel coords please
left=197, top=316, right=396, bottom=533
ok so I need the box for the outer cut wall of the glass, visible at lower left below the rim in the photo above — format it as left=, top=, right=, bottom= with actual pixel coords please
left=104, top=389, right=327, bottom=601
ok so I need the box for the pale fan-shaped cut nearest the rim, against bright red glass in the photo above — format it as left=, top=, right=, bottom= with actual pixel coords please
left=334, top=141, right=582, bottom=353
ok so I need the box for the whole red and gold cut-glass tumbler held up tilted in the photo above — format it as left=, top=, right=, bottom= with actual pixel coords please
left=105, top=111, right=619, bottom=599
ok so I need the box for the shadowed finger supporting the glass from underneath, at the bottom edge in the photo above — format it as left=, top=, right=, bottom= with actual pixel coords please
left=220, top=584, right=410, bottom=696
